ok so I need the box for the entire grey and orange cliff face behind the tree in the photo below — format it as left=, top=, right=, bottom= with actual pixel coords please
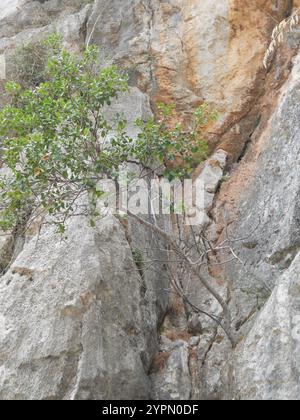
left=0, top=0, right=300, bottom=400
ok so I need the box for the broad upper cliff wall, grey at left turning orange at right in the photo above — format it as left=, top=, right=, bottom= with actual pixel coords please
left=87, top=0, right=290, bottom=160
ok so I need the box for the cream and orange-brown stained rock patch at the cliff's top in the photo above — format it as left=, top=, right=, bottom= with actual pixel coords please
left=151, top=0, right=291, bottom=163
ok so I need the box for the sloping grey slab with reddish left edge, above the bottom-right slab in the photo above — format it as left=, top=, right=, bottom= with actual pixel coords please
left=215, top=51, right=300, bottom=328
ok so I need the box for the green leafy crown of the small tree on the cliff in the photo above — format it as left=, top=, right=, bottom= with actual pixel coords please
left=0, top=35, right=214, bottom=232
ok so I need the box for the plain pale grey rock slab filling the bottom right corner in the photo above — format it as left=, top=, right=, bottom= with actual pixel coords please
left=232, top=254, right=300, bottom=400
